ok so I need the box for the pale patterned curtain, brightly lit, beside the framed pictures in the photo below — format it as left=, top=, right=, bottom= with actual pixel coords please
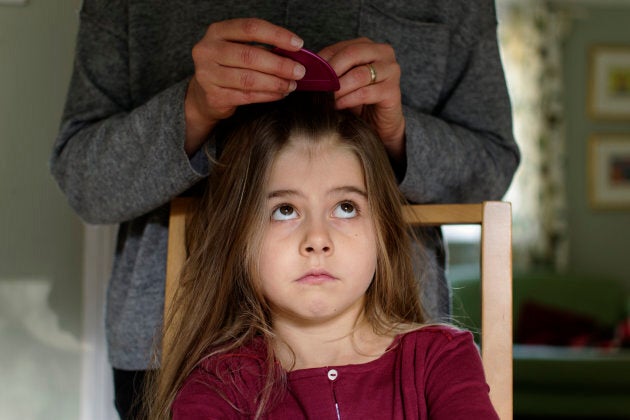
left=497, top=0, right=569, bottom=271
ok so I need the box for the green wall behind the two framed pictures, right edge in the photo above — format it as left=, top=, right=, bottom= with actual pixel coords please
left=564, top=2, right=630, bottom=290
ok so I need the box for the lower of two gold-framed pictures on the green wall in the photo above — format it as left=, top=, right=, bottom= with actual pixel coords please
left=589, top=134, right=630, bottom=210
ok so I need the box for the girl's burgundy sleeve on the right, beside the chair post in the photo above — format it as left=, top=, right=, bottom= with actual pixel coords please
left=424, top=330, right=499, bottom=420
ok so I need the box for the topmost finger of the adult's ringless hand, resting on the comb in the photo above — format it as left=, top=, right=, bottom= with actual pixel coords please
left=208, top=18, right=304, bottom=51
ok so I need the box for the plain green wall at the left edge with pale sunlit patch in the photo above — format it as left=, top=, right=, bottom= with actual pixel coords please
left=0, top=0, right=83, bottom=419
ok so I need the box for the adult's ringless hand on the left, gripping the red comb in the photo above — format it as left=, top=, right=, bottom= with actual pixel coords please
left=184, top=18, right=305, bottom=155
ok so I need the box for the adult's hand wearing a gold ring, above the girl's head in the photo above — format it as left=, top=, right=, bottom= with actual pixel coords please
left=319, top=38, right=405, bottom=162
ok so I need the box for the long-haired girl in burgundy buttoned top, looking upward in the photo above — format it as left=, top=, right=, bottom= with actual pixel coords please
left=150, top=93, right=497, bottom=420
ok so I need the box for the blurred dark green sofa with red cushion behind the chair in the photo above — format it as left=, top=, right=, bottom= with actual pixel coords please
left=451, top=273, right=630, bottom=419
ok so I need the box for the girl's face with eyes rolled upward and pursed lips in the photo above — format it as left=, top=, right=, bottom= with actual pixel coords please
left=259, top=138, right=377, bottom=324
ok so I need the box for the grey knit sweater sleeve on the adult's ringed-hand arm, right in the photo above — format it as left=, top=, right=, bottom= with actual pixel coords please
left=398, top=0, right=520, bottom=202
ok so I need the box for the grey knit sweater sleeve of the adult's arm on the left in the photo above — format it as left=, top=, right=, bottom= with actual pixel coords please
left=50, top=0, right=207, bottom=223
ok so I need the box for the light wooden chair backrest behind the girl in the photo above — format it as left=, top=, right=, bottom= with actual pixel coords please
left=162, top=198, right=513, bottom=420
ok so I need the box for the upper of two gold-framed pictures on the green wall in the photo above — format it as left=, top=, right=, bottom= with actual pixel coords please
left=588, top=45, right=630, bottom=120
